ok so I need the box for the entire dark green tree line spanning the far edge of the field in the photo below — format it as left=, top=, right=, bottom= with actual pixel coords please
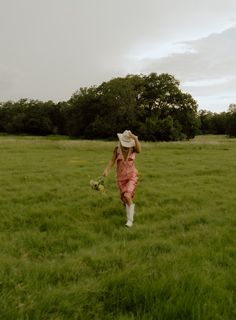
left=0, top=73, right=236, bottom=141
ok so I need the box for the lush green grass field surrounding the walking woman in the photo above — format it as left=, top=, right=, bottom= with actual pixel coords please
left=0, top=136, right=236, bottom=320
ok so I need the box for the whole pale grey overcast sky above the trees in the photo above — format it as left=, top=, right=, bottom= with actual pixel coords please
left=0, top=0, right=236, bottom=112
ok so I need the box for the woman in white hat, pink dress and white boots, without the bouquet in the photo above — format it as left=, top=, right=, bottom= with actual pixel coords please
left=103, top=130, right=141, bottom=227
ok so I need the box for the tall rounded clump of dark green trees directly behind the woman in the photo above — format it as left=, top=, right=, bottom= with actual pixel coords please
left=64, top=73, right=198, bottom=141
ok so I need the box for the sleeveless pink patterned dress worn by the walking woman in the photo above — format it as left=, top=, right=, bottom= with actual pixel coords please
left=116, top=147, right=138, bottom=202
